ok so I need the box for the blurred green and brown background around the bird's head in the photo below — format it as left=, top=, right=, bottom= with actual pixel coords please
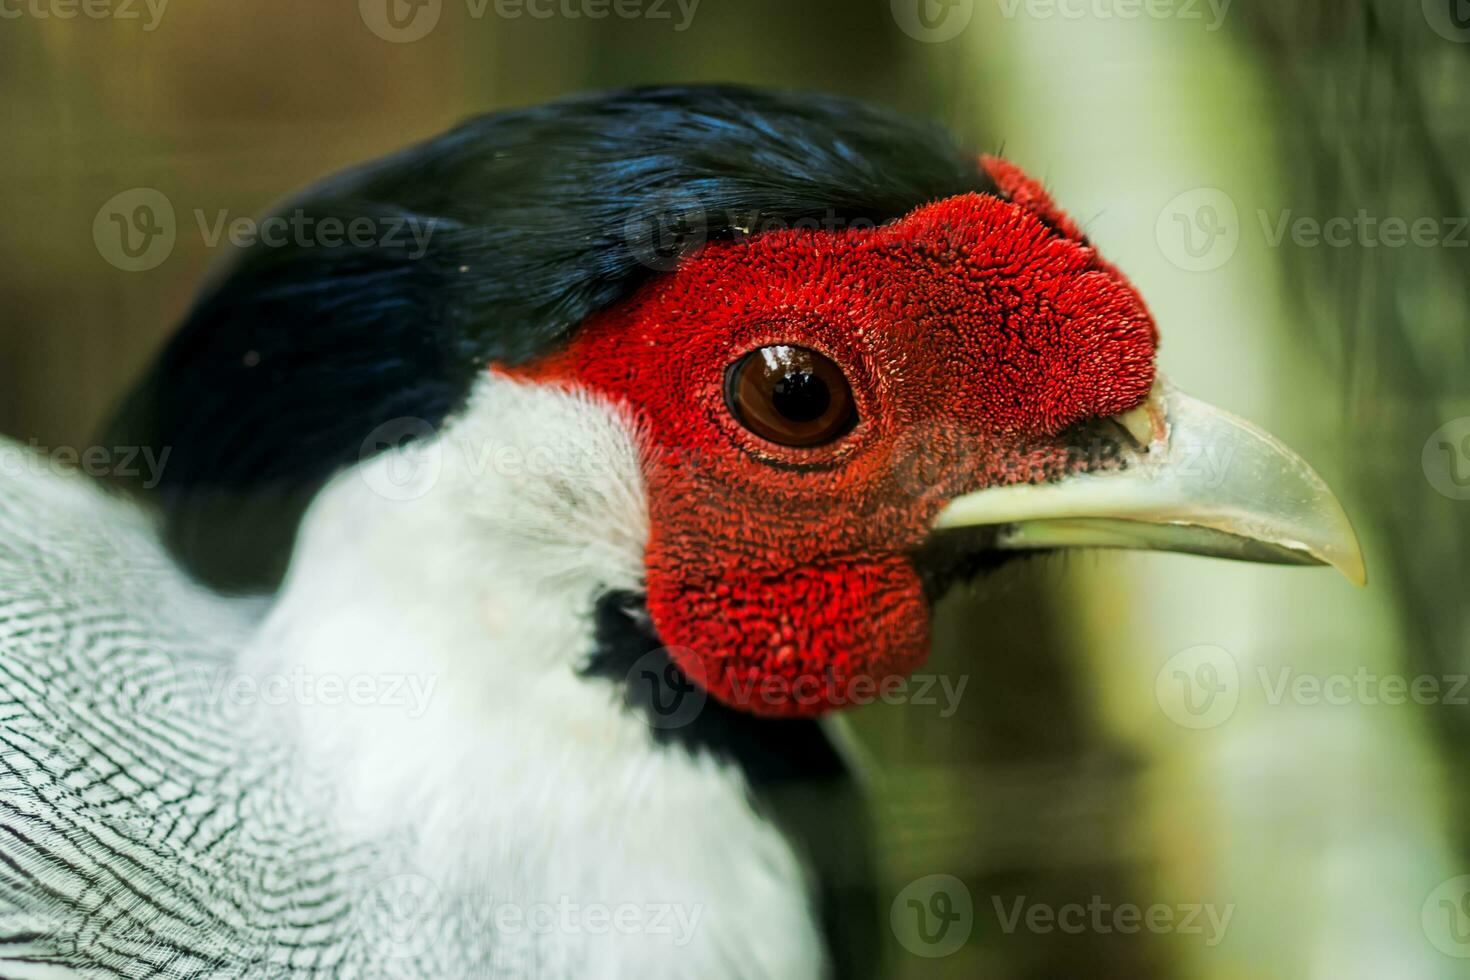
left=0, top=0, right=1470, bottom=980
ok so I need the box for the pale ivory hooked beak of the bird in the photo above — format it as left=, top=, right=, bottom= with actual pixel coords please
left=935, top=379, right=1367, bottom=585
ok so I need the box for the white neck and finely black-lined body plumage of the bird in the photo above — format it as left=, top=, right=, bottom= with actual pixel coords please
left=0, top=378, right=822, bottom=977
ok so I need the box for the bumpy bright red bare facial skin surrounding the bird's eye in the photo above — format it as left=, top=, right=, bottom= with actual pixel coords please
left=510, top=160, right=1155, bottom=716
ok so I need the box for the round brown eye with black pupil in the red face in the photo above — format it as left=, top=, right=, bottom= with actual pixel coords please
left=725, top=347, right=857, bottom=447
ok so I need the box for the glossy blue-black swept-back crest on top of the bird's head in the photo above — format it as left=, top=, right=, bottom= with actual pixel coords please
left=104, top=87, right=995, bottom=589
